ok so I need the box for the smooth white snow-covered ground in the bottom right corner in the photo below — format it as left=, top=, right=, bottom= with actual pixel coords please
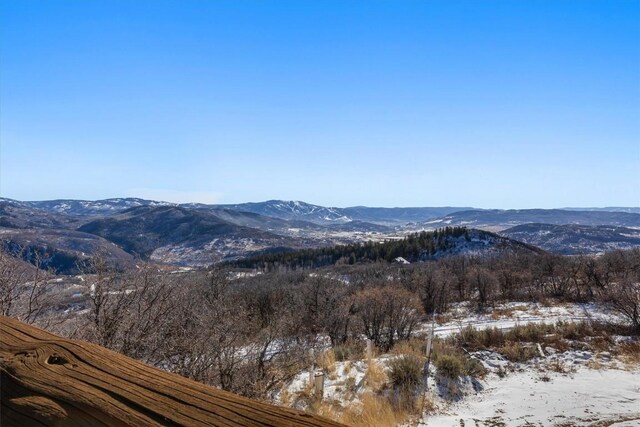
left=420, top=366, right=640, bottom=427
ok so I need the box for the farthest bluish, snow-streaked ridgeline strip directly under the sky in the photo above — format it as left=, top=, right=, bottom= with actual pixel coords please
left=6, top=198, right=640, bottom=227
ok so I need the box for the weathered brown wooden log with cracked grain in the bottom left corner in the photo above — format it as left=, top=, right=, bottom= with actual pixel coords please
left=0, top=316, right=340, bottom=427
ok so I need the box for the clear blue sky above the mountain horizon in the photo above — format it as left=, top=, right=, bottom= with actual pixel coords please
left=0, top=0, right=640, bottom=208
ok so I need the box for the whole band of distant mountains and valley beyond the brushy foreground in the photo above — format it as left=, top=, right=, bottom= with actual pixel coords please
left=0, top=198, right=640, bottom=272
